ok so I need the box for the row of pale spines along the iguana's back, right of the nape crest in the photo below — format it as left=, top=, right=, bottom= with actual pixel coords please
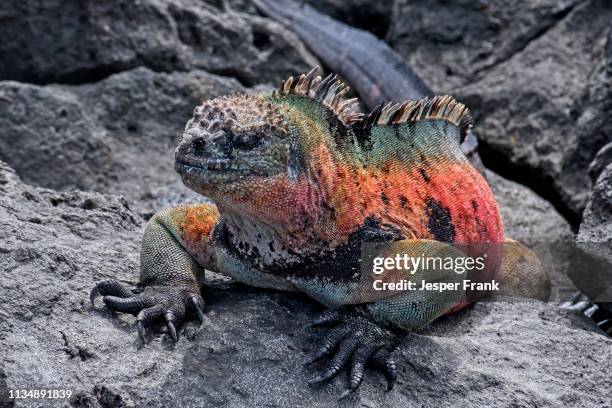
left=366, top=95, right=472, bottom=133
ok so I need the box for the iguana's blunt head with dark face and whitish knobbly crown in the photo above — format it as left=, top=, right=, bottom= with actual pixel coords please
left=175, top=94, right=288, bottom=194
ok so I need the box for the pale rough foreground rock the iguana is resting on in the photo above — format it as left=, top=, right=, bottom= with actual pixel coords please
left=0, top=164, right=612, bottom=407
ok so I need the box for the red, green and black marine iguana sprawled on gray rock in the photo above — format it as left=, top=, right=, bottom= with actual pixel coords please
left=92, top=70, right=546, bottom=395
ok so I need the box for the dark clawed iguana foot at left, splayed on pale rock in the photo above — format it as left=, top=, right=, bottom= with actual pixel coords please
left=89, top=280, right=204, bottom=342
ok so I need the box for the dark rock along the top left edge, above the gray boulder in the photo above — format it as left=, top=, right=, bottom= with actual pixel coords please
left=0, top=0, right=315, bottom=85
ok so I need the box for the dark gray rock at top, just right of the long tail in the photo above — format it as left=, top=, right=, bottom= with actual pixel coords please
left=388, top=0, right=581, bottom=90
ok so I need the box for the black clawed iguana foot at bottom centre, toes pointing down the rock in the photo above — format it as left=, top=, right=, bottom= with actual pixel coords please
left=306, top=309, right=400, bottom=399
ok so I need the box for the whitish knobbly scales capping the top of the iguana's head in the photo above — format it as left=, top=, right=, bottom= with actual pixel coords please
left=194, top=94, right=287, bottom=134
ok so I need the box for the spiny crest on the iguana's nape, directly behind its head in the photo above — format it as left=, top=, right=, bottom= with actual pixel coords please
left=278, top=67, right=363, bottom=125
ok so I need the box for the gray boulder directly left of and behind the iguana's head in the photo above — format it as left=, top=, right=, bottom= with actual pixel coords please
left=0, top=68, right=243, bottom=206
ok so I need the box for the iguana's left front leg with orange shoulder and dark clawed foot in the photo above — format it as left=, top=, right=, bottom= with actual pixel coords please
left=90, top=204, right=219, bottom=341
